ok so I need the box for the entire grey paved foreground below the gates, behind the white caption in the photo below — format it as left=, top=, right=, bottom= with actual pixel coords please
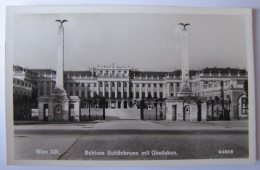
left=14, top=120, right=249, bottom=160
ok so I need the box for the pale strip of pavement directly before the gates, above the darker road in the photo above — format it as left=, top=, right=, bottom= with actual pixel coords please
left=14, top=120, right=248, bottom=133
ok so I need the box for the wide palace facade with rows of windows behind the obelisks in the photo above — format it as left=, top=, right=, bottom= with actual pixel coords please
left=13, top=65, right=248, bottom=119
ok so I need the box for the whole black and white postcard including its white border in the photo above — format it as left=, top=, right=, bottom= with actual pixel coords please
left=6, top=6, right=256, bottom=166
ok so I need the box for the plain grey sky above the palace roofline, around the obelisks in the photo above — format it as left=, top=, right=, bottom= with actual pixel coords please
left=14, top=14, right=246, bottom=71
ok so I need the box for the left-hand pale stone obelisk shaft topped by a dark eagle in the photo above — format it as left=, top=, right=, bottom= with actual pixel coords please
left=55, top=20, right=67, bottom=92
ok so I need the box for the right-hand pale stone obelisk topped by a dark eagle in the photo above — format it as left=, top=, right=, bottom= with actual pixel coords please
left=178, top=23, right=192, bottom=96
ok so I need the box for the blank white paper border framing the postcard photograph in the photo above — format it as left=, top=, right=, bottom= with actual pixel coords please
left=5, top=6, right=256, bottom=166
